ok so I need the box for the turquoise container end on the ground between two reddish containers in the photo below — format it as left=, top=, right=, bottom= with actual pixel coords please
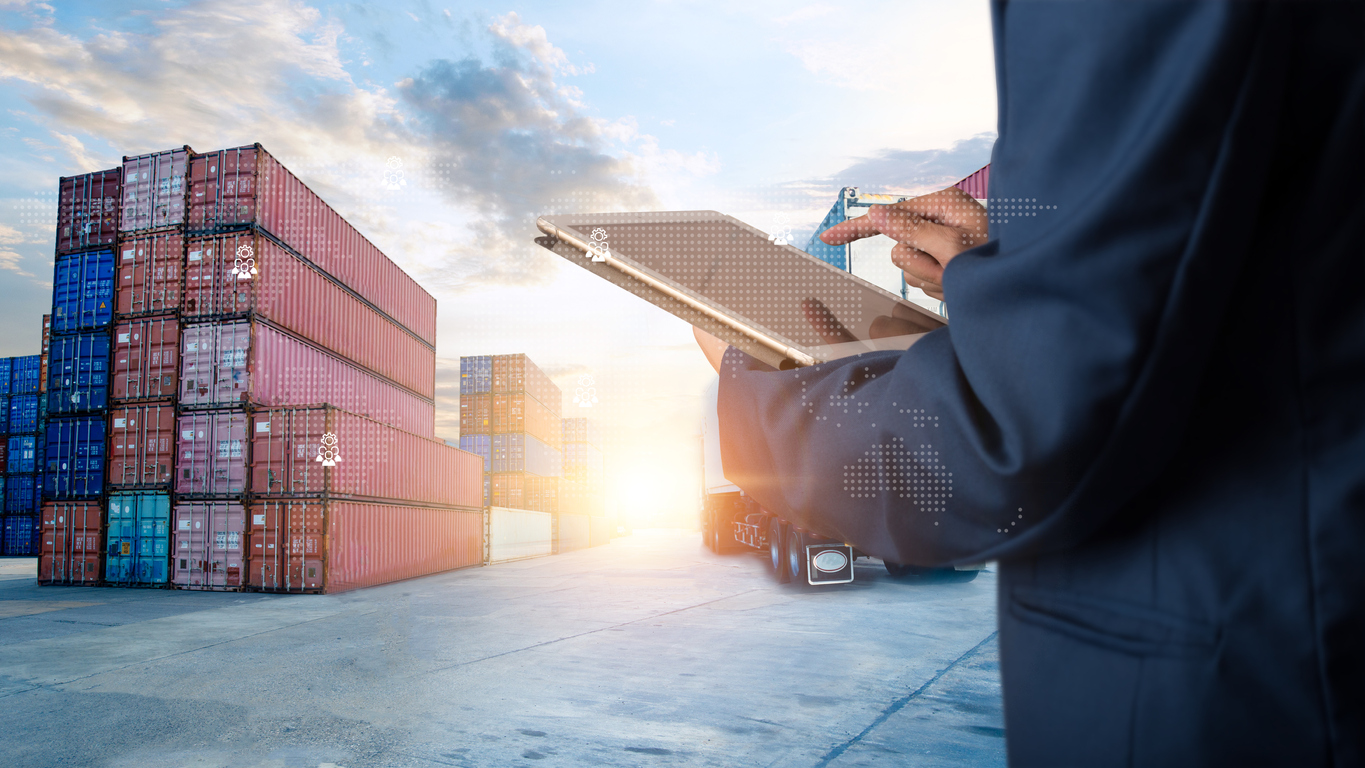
left=104, top=491, right=171, bottom=584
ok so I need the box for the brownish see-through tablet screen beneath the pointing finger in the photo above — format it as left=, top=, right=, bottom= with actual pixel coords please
left=545, top=211, right=946, bottom=360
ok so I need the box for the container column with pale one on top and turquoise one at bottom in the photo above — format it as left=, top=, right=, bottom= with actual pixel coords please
left=104, top=146, right=194, bottom=587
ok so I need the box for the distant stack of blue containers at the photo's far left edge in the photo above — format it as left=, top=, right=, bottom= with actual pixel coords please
left=0, top=355, right=45, bottom=555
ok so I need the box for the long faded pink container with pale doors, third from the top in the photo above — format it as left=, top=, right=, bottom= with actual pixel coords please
left=180, top=321, right=435, bottom=438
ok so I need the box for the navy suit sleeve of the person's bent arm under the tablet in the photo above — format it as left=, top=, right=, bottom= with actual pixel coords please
left=718, top=3, right=1282, bottom=565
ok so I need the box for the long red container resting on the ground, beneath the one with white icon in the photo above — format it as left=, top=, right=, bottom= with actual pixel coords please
left=247, top=499, right=483, bottom=593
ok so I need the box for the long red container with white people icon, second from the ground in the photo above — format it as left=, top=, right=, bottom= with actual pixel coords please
left=250, top=405, right=483, bottom=509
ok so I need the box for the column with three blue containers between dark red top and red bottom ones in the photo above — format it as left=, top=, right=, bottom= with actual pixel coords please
left=38, top=168, right=123, bottom=584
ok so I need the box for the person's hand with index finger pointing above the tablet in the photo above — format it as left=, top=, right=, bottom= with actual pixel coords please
left=820, top=187, right=987, bottom=301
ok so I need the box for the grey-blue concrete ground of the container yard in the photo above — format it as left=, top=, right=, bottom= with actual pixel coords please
left=0, top=531, right=1005, bottom=768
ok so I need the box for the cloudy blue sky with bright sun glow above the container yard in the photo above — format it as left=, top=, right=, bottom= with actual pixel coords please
left=0, top=0, right=995, bottom=527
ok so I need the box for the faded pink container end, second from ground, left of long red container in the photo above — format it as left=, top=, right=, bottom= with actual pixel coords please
left=175, top=409, right=251, bottom=497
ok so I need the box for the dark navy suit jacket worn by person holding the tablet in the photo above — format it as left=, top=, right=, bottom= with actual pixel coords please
left=718, top=1, right=1365, bottom=767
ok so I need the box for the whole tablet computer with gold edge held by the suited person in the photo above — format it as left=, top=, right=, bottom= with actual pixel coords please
left=536, top=210, right=947, bottom=370
